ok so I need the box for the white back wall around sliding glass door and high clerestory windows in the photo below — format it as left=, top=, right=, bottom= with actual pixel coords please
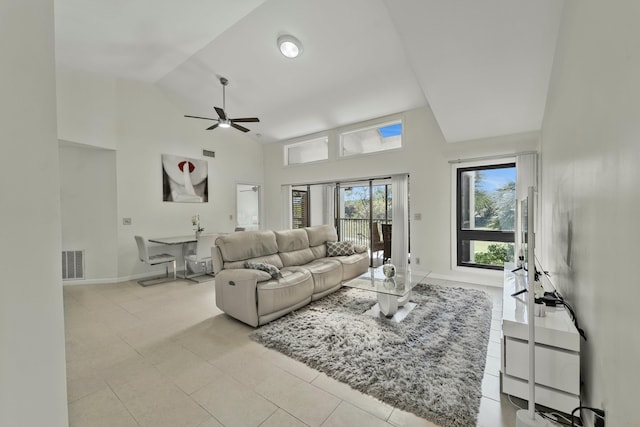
left=265, top=107, right=539, bottom=285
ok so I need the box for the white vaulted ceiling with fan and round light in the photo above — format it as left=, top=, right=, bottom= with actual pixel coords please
left=55, top=0, right=563, bottom=142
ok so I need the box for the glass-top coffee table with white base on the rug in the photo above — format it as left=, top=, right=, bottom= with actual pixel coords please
left=342, top=267, right=429, bottom=322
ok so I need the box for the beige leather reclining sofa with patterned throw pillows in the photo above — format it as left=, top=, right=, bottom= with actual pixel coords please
left=211, top=225, right=369, bottom=326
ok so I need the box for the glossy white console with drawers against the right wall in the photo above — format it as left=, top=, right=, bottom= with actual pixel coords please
left=500, top=263, right=580, bottom=413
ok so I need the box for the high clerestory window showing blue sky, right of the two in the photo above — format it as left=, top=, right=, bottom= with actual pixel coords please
left=340, top=121, right=402, bottom=157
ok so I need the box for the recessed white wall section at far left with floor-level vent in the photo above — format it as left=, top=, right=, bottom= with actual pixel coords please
left=59, top=142, right=118, bottom=284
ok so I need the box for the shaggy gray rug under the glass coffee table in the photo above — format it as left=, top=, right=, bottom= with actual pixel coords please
left=251, top=284, right=492, bottom=427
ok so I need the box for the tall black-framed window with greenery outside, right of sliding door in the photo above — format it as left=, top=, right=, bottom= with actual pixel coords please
left=456, top=163, right=516, bottom=270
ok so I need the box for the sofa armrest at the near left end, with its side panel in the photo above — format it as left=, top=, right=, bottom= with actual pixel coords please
left=215, top=268, right=271, bottom=326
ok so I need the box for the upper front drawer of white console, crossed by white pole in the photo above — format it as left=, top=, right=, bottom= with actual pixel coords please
left=504, top=337, right=580, bottom=394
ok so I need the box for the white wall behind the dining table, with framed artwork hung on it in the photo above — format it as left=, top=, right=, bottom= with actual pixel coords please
left=116, top=80, right=263, bottom=277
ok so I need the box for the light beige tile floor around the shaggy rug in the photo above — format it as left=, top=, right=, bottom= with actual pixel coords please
left=64, top=280, right=528, bottom=427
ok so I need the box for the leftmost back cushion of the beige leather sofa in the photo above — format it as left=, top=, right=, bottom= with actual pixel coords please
left=216, top=230, right=278, bottom=262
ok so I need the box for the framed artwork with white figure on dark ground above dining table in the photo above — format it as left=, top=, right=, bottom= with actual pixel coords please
left=162, top=154, right=209, bottom=203
